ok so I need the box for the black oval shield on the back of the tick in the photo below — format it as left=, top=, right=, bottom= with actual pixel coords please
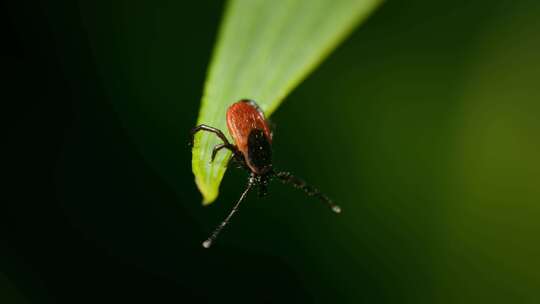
left=246, top=129, right=272, bottom=176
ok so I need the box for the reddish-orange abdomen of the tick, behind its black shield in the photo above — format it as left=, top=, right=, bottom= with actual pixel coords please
left=227, top=100, right=272, bottom=156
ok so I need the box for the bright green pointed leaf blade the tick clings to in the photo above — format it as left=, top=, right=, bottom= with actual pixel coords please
left=192, top=0, right=381, bottom=204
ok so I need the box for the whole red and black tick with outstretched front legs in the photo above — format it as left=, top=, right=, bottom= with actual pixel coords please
left=190, top=99, right=341, bottom=248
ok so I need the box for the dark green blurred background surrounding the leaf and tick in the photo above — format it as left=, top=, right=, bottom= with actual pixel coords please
left=5, top=0, right=540, bottom=303
